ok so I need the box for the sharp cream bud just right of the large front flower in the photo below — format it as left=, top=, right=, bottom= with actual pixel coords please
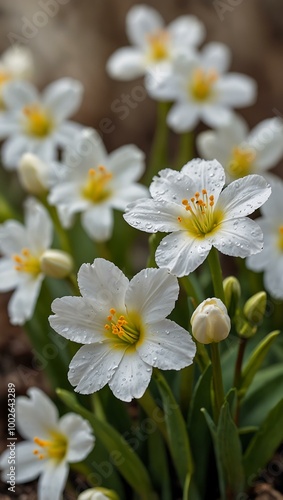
left=191, top=297, right=231, bottom=344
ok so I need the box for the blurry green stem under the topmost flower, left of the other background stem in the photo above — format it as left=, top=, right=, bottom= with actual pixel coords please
left=144, top=102, right=170, bottom=186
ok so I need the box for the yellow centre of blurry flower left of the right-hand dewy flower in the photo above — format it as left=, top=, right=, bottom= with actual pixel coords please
left=82, top=165, right=112, bottom=203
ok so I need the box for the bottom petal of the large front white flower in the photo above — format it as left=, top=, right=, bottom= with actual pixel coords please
left=109, top=348, right=152, bottom=402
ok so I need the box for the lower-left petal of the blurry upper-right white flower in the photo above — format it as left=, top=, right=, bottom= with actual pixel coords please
left=167, top=102, right=200, bottom=134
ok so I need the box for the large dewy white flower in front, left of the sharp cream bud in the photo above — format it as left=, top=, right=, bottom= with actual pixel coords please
left=49, top=259, right=195, bottom=401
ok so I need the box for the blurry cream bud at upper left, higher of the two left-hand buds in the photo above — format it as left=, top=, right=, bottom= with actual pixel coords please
left=18, top=153, right=48, bottom=195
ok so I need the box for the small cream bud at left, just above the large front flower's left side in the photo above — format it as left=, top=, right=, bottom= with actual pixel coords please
left=40, top=249, right=73, bottom=278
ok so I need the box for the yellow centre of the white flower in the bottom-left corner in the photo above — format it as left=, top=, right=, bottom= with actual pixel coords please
left=33, top=431, right=68, bottom=461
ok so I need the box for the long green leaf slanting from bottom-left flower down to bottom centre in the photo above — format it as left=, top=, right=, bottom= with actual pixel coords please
left=56, top=389, right=154, bottom=500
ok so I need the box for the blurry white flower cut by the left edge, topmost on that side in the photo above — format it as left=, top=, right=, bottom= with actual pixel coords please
left=0, top=45, right=34, bottom=107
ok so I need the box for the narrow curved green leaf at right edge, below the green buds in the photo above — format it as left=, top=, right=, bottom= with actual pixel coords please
left=239, top=330, right=280, bottom=399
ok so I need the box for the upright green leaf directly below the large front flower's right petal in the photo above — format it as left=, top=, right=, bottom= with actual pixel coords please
left=154, top=370, right=193, bottom=485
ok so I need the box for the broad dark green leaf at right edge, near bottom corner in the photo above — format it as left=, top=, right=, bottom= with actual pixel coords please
left=243, top=398, right=283, bottom=481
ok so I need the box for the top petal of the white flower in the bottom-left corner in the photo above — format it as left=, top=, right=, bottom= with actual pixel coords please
left=16, top=387, right=59, bottom=440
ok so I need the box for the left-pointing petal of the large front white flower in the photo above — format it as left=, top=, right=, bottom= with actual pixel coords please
left=49, top=296, right=107, bottom=344
